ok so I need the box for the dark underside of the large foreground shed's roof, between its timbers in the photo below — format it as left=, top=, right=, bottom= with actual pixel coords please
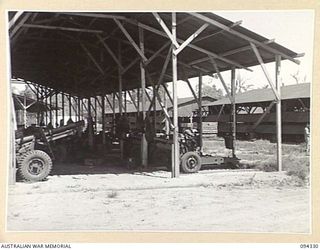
left=9, top=12, right=299, bottom=97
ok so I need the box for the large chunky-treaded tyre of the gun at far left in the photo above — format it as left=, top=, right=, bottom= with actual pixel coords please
left=18, top=150, right=52, bottom=182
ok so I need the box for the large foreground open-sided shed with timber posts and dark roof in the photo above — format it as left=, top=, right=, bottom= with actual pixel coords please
left=8, top=11, right=300, bottom=182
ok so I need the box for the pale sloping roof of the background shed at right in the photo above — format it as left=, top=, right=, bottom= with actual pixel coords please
left=203, top=83, right=310, bottom=106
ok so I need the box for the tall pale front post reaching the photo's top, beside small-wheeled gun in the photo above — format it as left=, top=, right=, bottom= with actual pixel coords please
left=172, top=12, right=180, bottom=178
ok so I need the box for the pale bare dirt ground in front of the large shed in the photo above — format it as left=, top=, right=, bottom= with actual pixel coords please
left=7, top=139, right=310, bottom=233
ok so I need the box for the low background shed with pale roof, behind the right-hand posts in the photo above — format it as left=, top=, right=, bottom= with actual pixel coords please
left=203, top=83, right=310, bottom=141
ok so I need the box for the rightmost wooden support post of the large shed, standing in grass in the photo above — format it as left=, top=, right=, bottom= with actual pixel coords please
left=275, top=55, right=282, bottom=171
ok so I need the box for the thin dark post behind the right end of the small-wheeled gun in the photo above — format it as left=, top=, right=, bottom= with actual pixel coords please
left=231, top=67, right=237, bottom=157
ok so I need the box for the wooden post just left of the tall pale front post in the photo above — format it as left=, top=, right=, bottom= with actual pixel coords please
left=139, top=27, right=148, bottom=167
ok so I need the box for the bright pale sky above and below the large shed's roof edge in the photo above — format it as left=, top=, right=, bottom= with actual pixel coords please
left=174, top=10, right=314, bottom=97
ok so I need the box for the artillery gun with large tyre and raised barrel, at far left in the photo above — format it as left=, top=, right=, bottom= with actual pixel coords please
left=15, top=121, right=85, bottom=181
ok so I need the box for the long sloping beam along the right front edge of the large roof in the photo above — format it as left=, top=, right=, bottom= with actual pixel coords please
left=189, top=12, right=300, bottom=64
